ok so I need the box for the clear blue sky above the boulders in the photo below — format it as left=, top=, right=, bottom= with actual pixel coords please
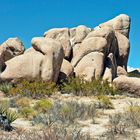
left=0, top=0, right=140, bottom=68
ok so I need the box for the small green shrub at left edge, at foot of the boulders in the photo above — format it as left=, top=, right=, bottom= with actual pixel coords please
left=0, top=82, right=13, bottom=94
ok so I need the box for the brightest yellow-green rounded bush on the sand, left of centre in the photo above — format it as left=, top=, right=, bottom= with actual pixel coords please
left=34, top=99, right=53, bottom=113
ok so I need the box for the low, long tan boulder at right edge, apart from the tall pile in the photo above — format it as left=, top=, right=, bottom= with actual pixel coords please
left=113, top=75, right=140, bottom=96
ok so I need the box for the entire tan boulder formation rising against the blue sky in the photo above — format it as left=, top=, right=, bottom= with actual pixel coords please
left=0, top=14, right=140, bottom=96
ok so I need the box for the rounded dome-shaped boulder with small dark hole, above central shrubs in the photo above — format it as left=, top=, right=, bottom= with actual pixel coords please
left=74, top=52, right=104, bottom=81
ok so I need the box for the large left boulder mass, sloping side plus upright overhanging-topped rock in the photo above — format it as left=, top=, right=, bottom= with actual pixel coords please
left=0, top=37, right=64, bottom=82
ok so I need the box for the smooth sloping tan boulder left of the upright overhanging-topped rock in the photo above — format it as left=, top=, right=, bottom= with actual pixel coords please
left=0, top=50, right=44, bottom=81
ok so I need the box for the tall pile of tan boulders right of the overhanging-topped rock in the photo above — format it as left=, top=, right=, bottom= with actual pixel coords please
left=44, top=14, right=130, bottom=82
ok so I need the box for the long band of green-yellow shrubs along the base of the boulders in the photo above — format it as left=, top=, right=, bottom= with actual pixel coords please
left=0, top=77, right=119, bottom=99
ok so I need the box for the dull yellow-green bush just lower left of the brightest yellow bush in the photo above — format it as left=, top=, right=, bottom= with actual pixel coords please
left=18, top=107, right=37, bottom=120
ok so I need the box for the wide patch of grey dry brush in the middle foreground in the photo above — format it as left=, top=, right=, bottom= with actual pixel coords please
left=33, top=101, right=97, bottom=124
